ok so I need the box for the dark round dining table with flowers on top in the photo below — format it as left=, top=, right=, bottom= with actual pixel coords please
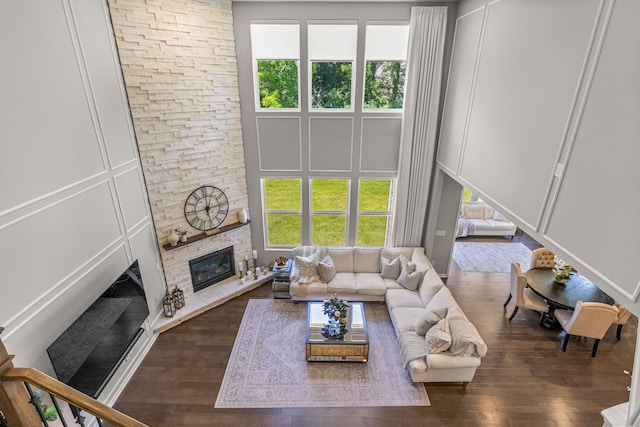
left=524, top=268, right=614, bottom=327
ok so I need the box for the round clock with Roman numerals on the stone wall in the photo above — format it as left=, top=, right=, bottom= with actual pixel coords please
left=184, top=185, right=229, bottom=231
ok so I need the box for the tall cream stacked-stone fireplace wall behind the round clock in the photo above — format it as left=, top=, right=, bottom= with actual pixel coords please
left=108, top=0, right=252, bottom=304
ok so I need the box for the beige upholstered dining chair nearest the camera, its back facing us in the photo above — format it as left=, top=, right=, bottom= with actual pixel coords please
left=554, top=301, right=619, bottom=357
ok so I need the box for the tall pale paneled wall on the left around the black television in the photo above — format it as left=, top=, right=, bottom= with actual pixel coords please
left=0, top=0, right=165, bottom=401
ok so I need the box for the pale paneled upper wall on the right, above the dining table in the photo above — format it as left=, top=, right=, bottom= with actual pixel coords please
left=438, top=0, right=640, bottom=314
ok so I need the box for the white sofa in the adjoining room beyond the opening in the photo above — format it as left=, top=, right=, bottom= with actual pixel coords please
left=456, top=202, right=518, bottom=237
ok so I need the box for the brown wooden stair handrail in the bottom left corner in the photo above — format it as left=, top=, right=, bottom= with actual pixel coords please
left=0, top=367, right=148, bottom=427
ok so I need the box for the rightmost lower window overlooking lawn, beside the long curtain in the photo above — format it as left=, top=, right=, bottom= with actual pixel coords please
left=356, top=179, right=393, bottom=246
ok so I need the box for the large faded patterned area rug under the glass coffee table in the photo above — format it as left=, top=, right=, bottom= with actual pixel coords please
left=215, top=299, right=430, bottom=408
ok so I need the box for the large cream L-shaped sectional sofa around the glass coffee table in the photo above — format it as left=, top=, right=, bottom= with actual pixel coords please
left=290, top=246, right=487, bottom=383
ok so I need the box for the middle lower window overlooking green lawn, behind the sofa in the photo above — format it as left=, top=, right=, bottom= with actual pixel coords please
left=310, top=179, right=349, bottom=246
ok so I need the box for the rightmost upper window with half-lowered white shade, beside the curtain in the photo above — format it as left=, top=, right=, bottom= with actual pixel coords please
left=363, top=25, right=409, bottom=110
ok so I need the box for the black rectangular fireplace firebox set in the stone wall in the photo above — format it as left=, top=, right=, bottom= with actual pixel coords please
left=189, top=246, right=236, bottom=292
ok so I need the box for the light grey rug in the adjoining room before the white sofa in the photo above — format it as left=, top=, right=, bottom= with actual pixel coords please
left=453, top=242, right=531, bottom=273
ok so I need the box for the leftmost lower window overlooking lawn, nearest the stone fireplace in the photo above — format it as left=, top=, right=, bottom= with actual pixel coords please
left=262, top=178, right=302, bottom=247
